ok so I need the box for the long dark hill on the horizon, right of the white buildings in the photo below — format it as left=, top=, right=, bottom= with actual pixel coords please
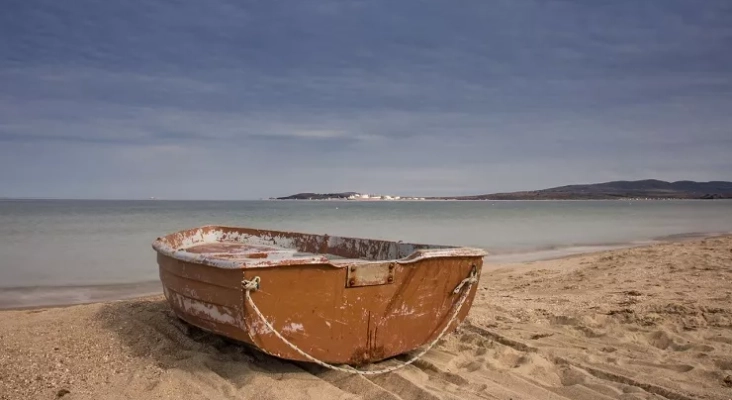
left=452, top=179, right=732, bottom=200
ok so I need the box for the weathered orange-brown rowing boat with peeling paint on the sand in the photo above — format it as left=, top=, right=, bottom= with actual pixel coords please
left=153, top=226, right=486, bottom=365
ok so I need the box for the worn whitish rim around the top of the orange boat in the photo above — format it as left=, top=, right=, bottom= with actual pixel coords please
left=152, top=224, right=488, bottom=269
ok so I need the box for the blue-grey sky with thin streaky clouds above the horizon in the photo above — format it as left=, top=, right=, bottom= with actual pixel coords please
left=0, top=0, right=732, bottom=199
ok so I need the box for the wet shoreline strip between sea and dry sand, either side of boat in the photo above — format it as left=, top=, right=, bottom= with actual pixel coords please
left=0, top=230, right=732, bottom=311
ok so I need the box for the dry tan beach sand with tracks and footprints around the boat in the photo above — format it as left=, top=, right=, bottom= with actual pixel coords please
left=0, top=237, right=732, bottom=400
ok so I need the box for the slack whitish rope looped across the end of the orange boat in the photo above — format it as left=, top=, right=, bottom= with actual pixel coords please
left=242, top=267, right=478, bottom=375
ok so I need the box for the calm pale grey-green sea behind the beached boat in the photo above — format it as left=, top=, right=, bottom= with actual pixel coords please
left=0, top=200, right=732, bottom=306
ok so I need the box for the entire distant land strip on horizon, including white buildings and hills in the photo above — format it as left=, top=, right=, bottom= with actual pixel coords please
left=270, top=179, right=732, bottom=201
